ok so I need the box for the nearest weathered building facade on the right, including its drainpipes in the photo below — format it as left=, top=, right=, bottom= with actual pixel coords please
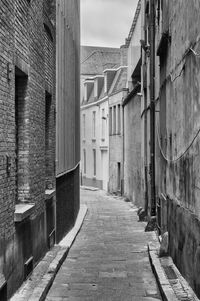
left=139, top=0, right=200, bottom=296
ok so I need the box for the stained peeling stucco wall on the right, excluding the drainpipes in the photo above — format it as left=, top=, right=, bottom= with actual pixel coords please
left=157, top=0, right=200, bottom=296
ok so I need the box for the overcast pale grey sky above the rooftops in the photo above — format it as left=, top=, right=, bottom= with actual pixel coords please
left=80, top=0, right=138, bottom=47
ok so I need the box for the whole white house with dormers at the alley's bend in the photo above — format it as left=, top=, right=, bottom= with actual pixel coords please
left=81, top=76, right=109, bottom=191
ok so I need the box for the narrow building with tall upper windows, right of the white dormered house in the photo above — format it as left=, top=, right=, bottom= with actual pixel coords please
left=108, top=66, right=127, bottom=194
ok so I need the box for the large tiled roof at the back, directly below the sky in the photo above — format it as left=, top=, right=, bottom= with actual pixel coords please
left=81, top=46, right=121, bottom=75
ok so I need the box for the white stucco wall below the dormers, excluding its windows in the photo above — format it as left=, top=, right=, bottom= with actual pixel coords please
left=81, top=99, right=109, bottom=190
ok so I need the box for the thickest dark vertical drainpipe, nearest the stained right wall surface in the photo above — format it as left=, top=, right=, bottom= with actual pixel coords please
left=150, top=0, right=156, bottom=216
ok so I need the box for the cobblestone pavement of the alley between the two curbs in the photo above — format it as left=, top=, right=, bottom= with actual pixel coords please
left=46, top=190, right=161, bottom=301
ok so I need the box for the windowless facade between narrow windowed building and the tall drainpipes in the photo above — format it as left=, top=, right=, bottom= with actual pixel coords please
left=123, top=1, right=141, bottom=208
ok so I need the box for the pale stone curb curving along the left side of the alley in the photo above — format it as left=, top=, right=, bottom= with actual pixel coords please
left=11, top=205, right=88, bottom=301
